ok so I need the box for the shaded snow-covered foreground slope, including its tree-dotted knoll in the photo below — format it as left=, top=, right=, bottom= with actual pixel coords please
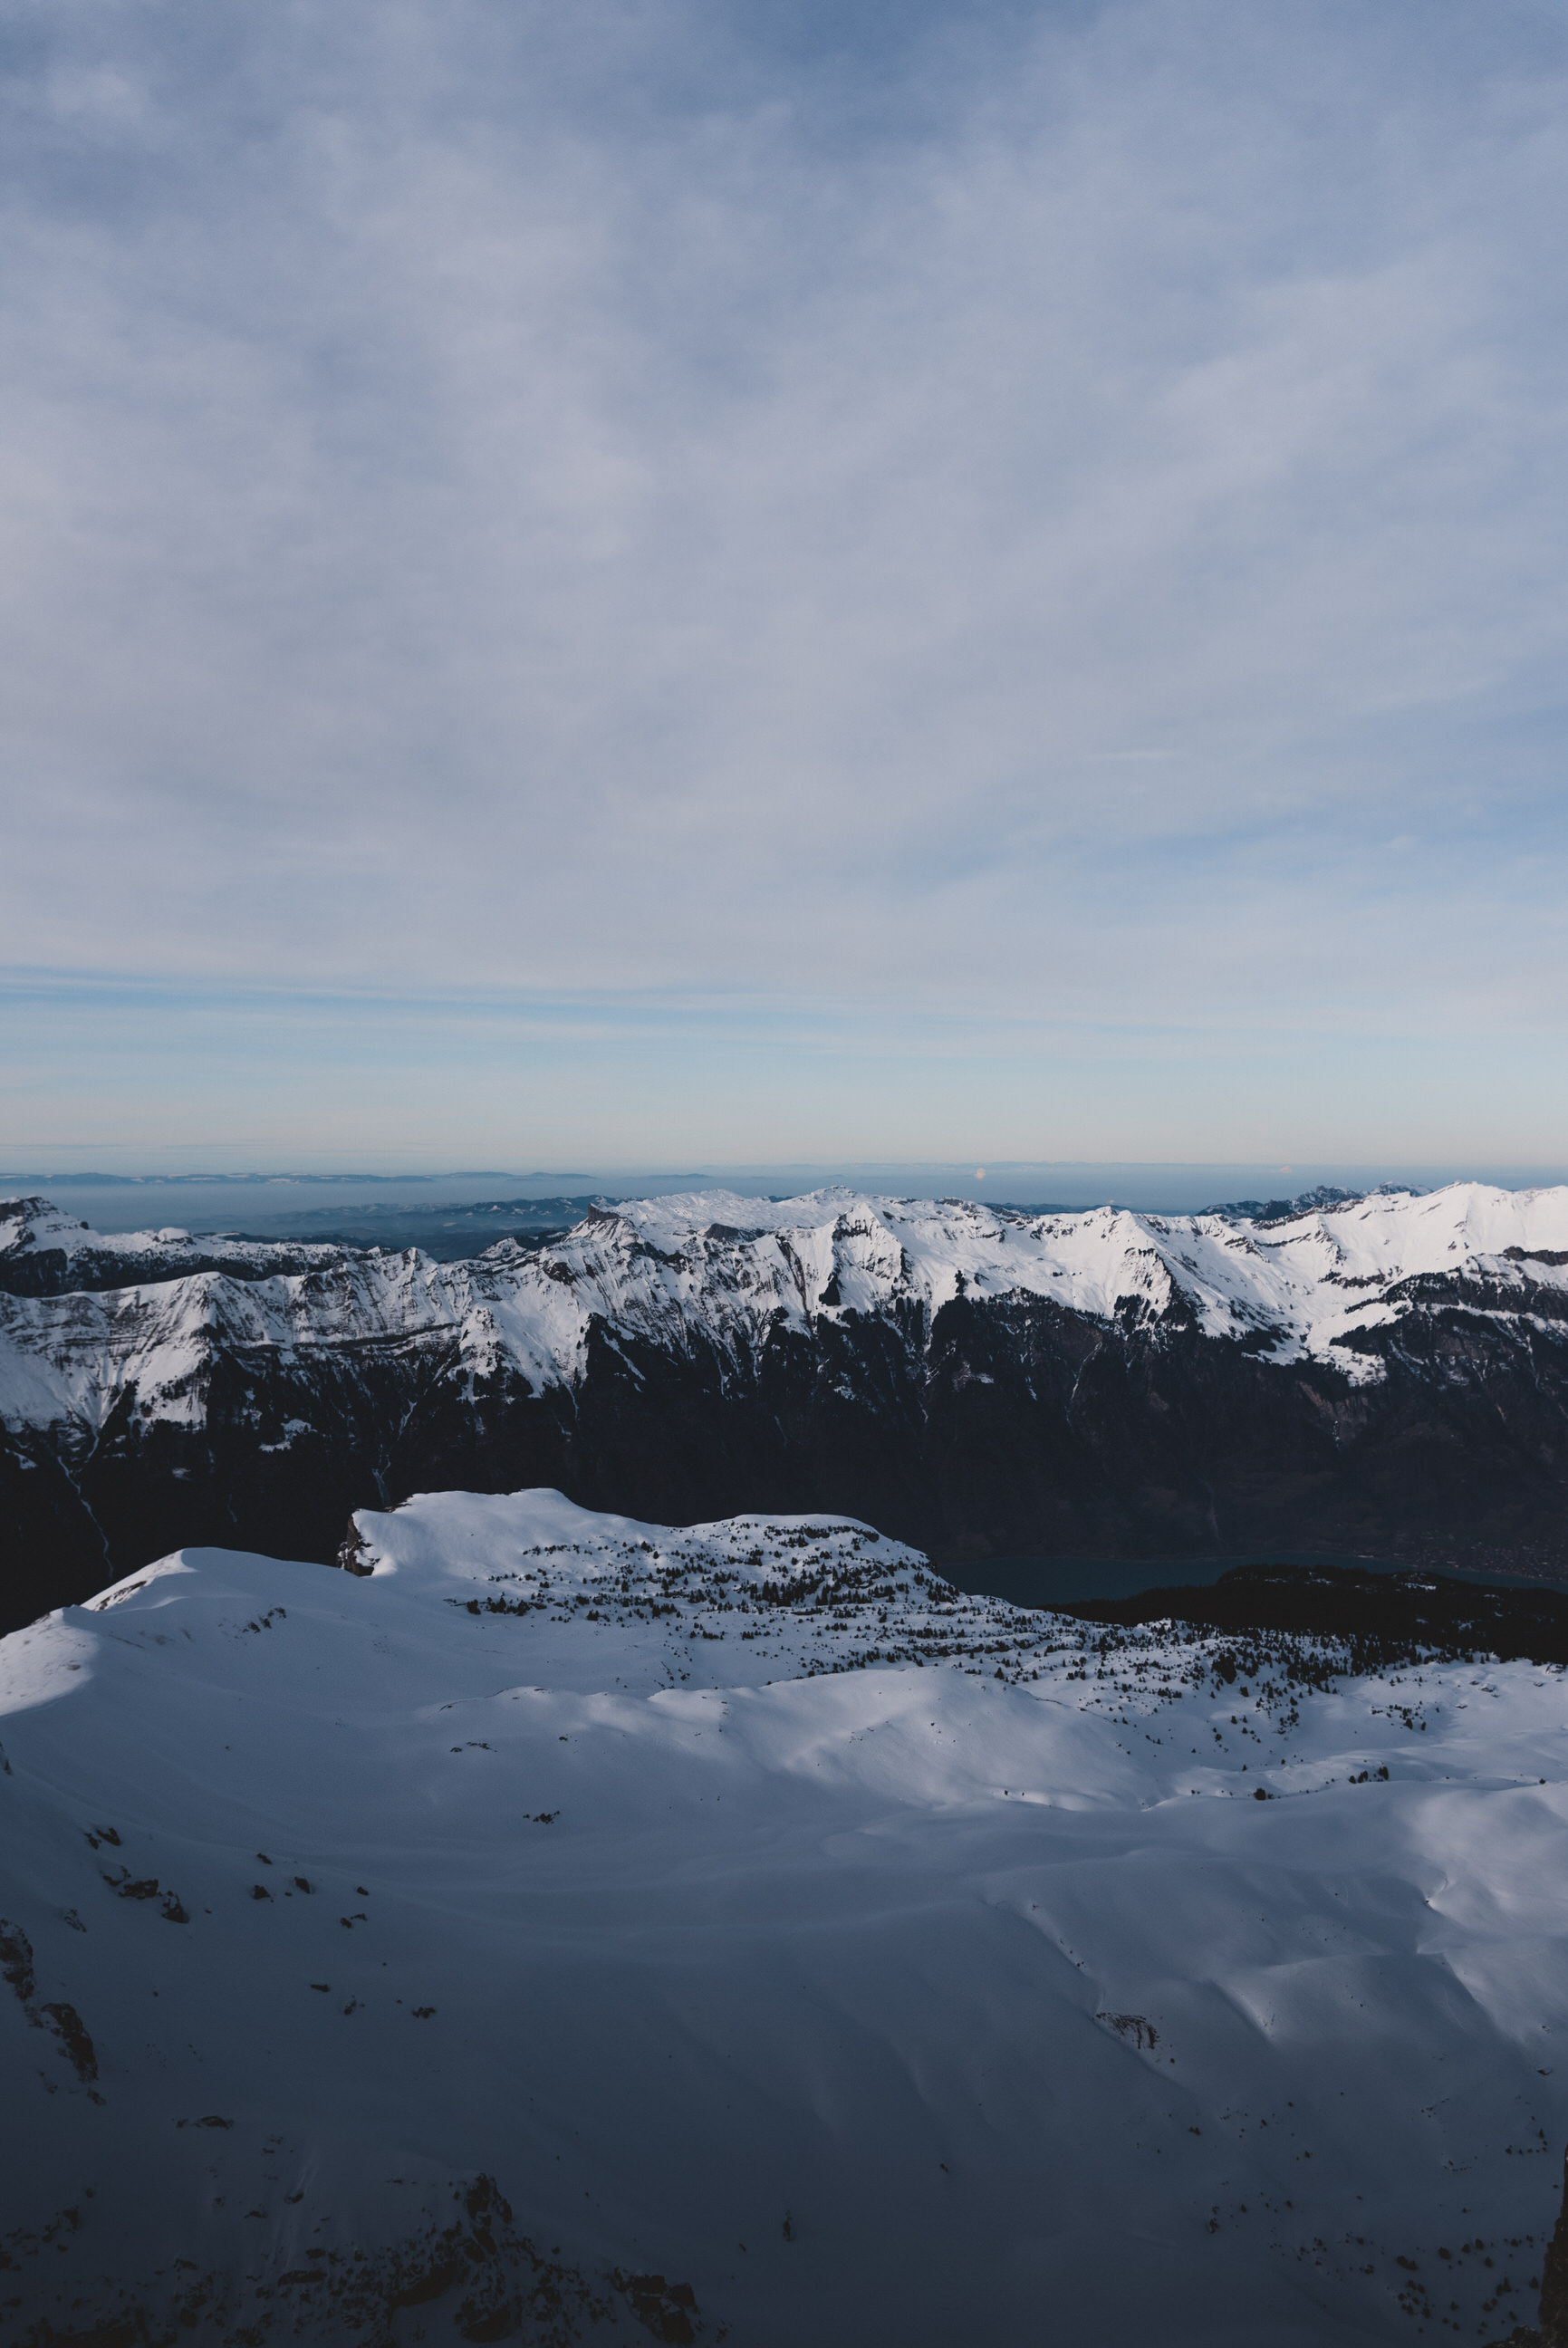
left=0, top=1493, right=1568, bottom=2348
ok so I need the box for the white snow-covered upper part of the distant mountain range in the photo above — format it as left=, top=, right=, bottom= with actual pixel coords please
left=0, top=1183, right=1568, bottom=1432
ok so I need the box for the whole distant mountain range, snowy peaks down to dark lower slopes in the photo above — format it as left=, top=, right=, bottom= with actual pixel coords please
left=0, top=1183, right=1568, bottom=1620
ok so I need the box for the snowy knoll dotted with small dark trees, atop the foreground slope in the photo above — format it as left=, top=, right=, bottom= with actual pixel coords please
left=331, top=1488, right=1539, bottom=1798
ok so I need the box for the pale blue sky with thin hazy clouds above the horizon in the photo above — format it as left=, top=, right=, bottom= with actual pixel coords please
left=0, top=0, right=1568, bottom=1169
